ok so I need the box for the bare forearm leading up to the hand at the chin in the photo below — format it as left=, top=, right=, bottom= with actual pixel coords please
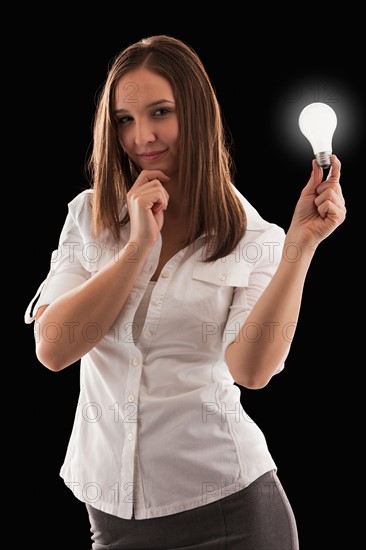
left=35, top=243, right=150, bottom=371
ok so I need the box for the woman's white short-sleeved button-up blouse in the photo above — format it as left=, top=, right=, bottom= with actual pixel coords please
left=25, top=188, right=285, bottom=519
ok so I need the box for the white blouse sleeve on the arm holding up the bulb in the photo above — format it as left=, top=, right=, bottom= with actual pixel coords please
left=223, top=225, right=285, bottom=372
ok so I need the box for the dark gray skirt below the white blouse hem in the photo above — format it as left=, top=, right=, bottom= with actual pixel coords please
left=86, top=471, right=299, bottom=550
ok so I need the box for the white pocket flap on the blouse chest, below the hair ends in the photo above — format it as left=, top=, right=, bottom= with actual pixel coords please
left=192, top=255, right=251, bottom=287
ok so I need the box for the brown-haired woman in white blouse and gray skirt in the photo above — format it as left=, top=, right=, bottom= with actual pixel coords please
left=26, top=36, right=346, bottom=550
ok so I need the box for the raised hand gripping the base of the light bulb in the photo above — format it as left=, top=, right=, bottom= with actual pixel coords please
left=289, top=155, right=346, bottom=244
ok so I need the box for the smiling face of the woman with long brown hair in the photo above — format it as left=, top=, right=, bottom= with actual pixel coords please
left=114, top=68, right=179, bottom=177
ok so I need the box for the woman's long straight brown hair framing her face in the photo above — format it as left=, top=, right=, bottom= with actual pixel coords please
left=87, top=35, right=246, bottom=261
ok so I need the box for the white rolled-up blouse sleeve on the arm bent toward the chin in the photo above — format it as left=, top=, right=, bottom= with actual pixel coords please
left=24, top=192, right=91, bottom=324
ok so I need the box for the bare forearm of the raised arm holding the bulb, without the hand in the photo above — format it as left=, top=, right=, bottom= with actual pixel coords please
left=226, top=234, right=314, bottom=388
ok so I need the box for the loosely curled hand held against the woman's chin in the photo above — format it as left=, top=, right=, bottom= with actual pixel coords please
left=127, top=170, right=169, bottom=245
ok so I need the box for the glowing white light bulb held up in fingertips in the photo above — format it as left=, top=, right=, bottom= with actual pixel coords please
left=299, top=103, right=337, bottom=168
